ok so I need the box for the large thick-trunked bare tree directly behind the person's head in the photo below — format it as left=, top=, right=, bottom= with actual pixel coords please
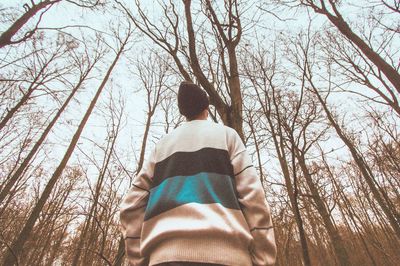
left=116, top=0, right=245, bottom=139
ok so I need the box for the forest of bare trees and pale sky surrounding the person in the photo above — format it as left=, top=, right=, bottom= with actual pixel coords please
left=0, top=0, right=400, bottom=266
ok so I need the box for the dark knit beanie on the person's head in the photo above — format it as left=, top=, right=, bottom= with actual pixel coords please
left=178, top=81, right=209, bottom=119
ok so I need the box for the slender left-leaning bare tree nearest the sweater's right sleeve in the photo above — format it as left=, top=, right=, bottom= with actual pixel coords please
left=243, top=45, right=311, bottom=265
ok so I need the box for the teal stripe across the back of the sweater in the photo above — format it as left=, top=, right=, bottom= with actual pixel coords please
left=144, top=172, right=240, bottom=220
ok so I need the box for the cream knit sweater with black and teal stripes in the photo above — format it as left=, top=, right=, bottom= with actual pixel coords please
left=120, top=120, right=276, bottom=266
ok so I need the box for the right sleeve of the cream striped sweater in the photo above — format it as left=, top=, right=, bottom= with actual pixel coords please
left=229, top=128, right=276, bottom=266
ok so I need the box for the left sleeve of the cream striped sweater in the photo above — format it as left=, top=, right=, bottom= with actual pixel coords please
left=120, top=150, right=155, bottom=266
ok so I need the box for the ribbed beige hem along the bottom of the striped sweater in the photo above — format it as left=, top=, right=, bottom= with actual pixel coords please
left=149, top=237, right=252, bottom=266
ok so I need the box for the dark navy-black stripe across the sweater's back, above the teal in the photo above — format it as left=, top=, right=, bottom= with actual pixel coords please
left=153, top=148, right=233, bottom=187
